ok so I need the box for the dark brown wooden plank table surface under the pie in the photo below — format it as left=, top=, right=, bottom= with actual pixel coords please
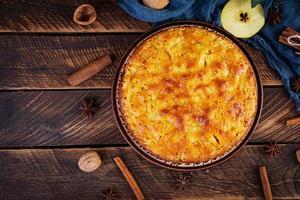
left=0, top=0, right=300, bottom=200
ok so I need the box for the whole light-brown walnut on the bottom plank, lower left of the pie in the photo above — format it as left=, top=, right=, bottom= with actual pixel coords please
left=78, top=151, right=101, bottom=172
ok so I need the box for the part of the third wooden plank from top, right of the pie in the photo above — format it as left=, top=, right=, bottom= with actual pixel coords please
left=251, top=87, right=300, bottom=143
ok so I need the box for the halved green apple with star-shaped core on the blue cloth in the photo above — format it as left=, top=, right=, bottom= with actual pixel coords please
left=221, top=0, right=265, bottom=38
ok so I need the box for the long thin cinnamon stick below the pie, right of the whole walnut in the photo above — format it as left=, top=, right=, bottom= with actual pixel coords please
left=114, top=157, right=145, bottom=200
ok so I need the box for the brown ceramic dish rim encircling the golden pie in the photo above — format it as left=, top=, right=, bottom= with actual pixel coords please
left=112, top=20, right=263, bottom=171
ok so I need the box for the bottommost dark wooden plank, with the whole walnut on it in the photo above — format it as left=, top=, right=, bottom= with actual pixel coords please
left=0, top=144, right=300, bottom=200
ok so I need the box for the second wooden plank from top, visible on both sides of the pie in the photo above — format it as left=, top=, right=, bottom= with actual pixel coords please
left=0, top=34, right=281, bottom=90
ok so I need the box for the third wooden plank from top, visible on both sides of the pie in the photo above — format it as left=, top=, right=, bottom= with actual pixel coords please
left=0, top=88, right=300, bottom=148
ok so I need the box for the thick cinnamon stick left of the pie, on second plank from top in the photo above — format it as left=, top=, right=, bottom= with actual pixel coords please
left=68, top=55, right=112, bottom=86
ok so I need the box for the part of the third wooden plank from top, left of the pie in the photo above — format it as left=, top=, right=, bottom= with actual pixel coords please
left=0, top=90, right=125, bottom=147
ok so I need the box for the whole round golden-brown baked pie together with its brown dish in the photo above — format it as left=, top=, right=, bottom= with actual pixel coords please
left=112, top=21, right=262, bottom=170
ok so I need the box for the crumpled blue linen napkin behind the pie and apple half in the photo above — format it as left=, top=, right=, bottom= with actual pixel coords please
left=118, top=0, right=300, bottom=113
